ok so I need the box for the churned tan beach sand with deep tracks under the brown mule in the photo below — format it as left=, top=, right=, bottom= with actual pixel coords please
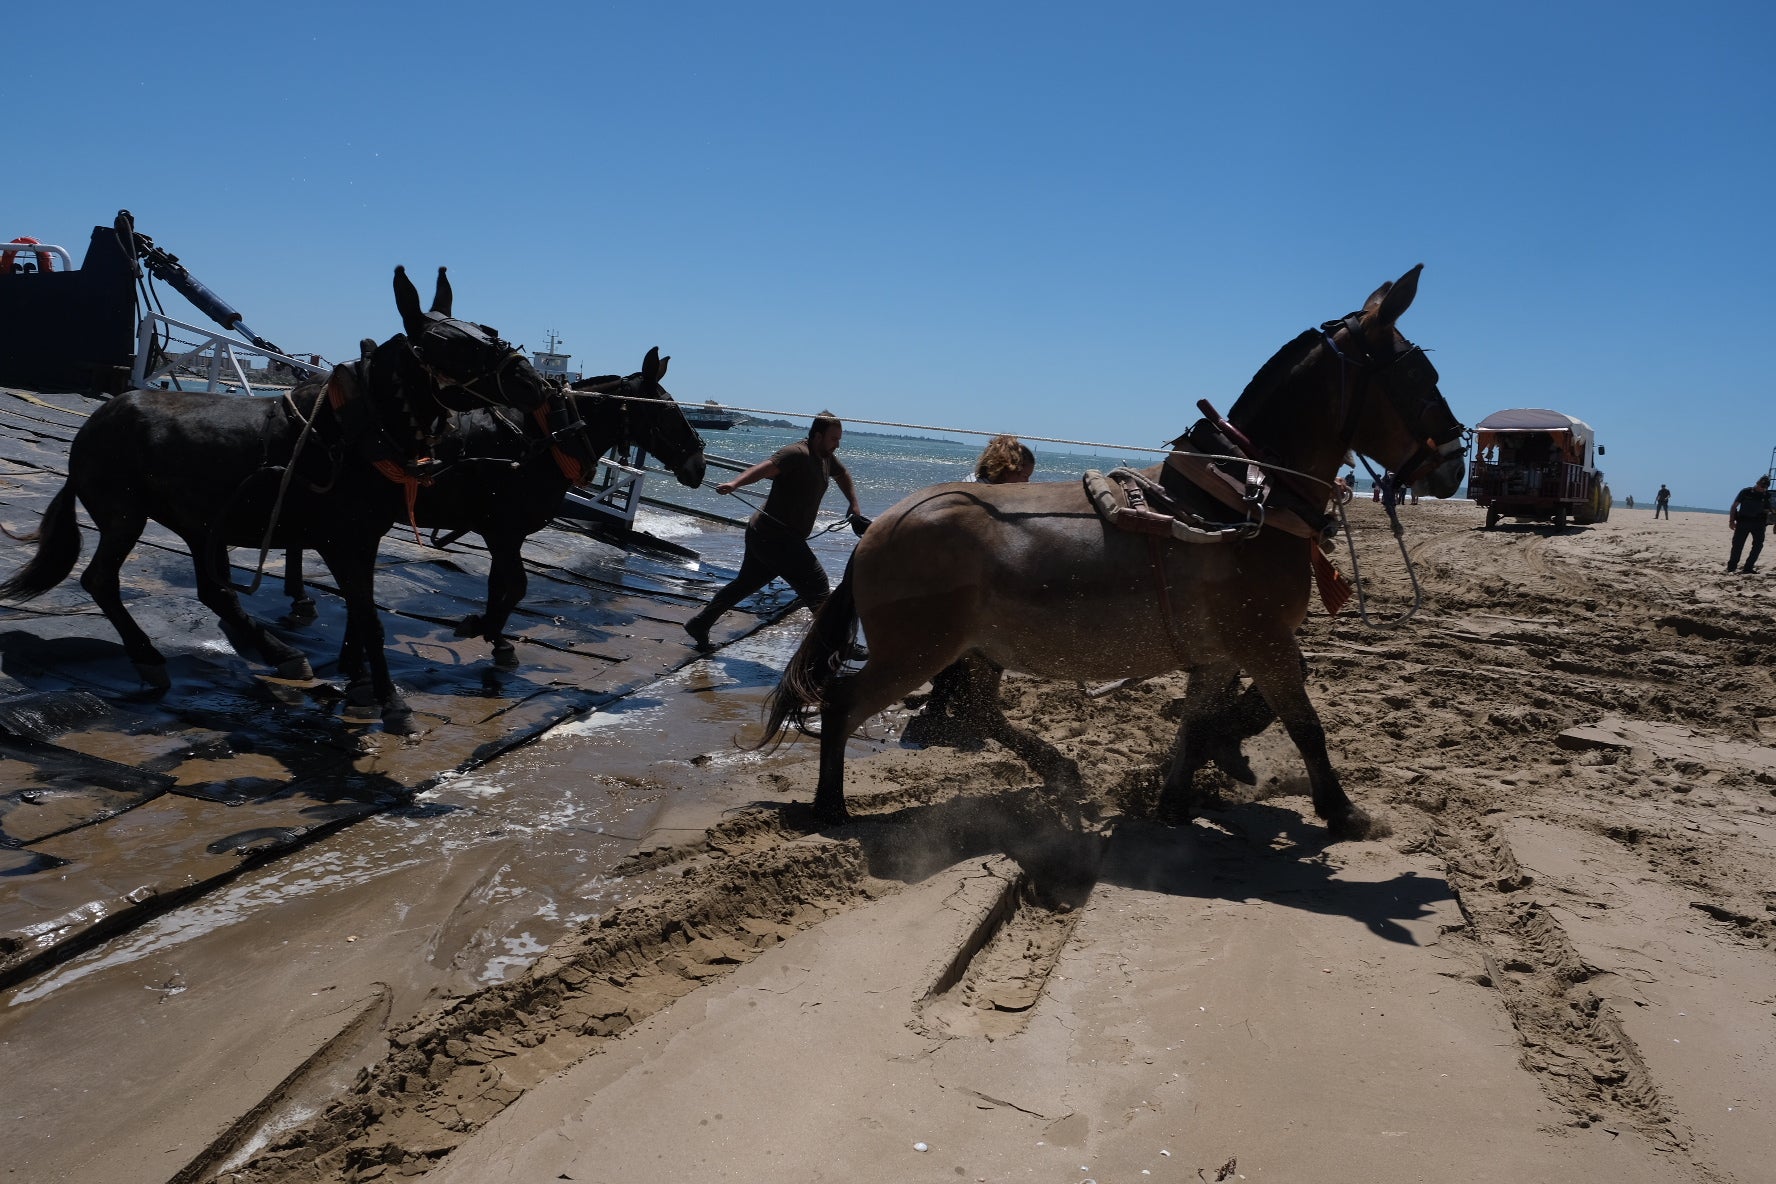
left=0, top=502, right=1776, bottom=1184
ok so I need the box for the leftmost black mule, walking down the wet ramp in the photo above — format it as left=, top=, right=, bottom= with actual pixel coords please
left=0, top=268, right=552, bottom=731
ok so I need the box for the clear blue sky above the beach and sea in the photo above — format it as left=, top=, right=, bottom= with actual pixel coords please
left=0, top=0, right=1776, bottom=508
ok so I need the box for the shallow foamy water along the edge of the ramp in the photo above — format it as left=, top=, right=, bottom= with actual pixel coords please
left=11, top=612, right=902, bottom=1003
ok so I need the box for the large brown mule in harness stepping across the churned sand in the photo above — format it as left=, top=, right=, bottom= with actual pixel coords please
left=764, top=268, right=1462, bottom=838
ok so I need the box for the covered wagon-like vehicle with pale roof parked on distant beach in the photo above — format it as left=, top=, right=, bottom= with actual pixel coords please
left=1467, top=407, right=1611, bottom=531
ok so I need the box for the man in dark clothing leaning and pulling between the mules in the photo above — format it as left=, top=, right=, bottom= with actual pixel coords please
left=684, top=412, right=865, bottom=650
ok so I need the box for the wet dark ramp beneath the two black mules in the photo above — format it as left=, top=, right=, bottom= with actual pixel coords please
left=0, top=387, right=790, bottom=985
